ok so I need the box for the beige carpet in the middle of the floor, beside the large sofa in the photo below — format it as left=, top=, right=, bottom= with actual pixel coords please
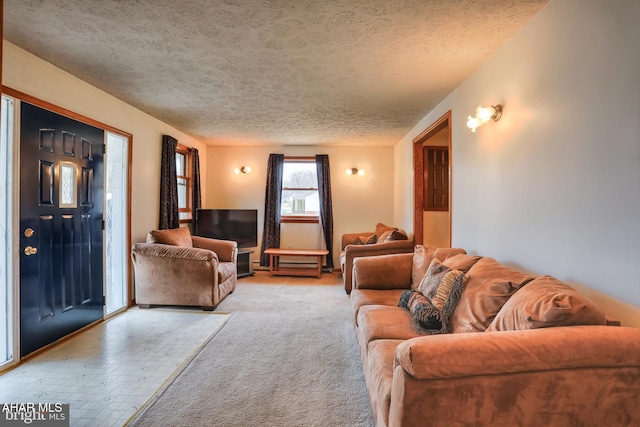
left=130, top=272, right=374, bottom=427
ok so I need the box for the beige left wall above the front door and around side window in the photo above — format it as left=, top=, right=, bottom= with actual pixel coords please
left=2, top=41, right=207, bottom=246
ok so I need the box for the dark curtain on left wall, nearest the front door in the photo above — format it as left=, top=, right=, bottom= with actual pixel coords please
left=158, top=135, right=180, bottom=230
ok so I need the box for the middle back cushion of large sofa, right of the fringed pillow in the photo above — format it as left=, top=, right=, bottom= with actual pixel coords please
left=451, top=257, right=534, bottom=333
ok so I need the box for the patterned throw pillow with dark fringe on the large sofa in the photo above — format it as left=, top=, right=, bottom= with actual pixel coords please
left=398, top=258, right=465, bottom=334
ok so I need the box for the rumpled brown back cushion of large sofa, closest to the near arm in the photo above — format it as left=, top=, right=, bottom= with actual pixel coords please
left=487, top=276, right=607, bottom=331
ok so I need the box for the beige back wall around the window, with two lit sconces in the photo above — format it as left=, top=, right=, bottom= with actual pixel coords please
left=204, top=146, right=393, bottom=267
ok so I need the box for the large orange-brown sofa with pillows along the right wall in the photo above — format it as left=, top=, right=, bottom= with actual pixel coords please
left=350, top=246, right=640, bottom=427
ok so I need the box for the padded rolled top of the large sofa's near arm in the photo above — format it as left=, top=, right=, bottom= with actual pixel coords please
left=394, top=326, right=640, bottom=380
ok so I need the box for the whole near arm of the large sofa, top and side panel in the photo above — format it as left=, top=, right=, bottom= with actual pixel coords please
left=387, top=326, right=640, bottom=426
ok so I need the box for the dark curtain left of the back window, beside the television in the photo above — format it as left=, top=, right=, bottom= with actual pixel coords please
left=260, top=154, right=284, bottom=267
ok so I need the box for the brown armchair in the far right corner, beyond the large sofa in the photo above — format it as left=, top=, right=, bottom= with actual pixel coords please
left=340, top=223, right=414, bottom=294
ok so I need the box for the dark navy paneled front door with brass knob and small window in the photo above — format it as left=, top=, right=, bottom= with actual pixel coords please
left=20, top=102, right=104, bottom=356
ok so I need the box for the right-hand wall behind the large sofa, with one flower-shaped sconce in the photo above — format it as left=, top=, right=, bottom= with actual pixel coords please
left=394, top=0, right=640, bottom=326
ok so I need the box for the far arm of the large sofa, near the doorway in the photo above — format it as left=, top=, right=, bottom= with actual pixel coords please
left=352, top=253, right=413, bottom=289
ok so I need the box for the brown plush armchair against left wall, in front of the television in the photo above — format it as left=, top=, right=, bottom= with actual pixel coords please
left=131, top=228, right=238, bottom=311
